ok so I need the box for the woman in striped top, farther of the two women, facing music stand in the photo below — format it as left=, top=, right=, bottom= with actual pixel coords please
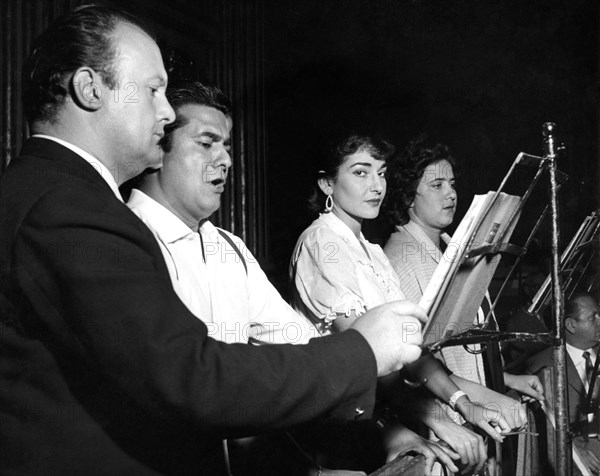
left=384, top=139, right=543, bottom=416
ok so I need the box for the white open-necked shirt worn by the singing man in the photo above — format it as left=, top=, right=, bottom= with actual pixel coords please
left=127, top=189, right=319, bottom=344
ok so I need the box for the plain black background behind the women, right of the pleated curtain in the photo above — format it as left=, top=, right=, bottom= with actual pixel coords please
left=264, top=0, right=599, bottom=304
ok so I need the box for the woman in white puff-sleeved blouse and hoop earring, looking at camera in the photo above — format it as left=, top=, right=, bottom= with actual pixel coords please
left=290, top=135, right=510, bottom=468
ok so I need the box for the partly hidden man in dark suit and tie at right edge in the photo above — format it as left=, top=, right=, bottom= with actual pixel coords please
left=527, top=294, right=600, bottom=472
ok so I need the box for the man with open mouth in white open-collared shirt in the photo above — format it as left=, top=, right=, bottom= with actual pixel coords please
left=128, top=82, right=318, bottom=344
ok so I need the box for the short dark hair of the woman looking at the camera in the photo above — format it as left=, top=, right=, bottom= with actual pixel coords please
left=308, top=134, right=395, bottom=212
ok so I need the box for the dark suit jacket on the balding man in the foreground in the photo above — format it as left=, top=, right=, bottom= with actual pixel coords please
left=0, top=138, right=376, bottom=476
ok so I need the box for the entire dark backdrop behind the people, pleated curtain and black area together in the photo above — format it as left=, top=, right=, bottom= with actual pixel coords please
left=0, top=0, right=599, bottom=308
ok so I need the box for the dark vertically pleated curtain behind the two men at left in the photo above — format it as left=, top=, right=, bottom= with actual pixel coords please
left=0, top=0, right=269, bottom=260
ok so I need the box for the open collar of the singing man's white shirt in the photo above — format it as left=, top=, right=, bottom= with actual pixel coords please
left=127, top=188, right=196, bottom=244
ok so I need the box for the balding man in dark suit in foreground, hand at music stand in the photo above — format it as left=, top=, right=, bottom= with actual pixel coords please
left=0, top=6, right=425, bottom=476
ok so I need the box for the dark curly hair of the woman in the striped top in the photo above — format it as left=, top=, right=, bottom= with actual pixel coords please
left=383, top=136, right=456, bottom=225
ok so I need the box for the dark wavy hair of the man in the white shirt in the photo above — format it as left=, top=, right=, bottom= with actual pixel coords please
left=160, top=81, right=231, bottom=152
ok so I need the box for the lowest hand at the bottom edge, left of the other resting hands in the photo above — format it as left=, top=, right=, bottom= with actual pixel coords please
left=384, top=425, right=460, bottom=474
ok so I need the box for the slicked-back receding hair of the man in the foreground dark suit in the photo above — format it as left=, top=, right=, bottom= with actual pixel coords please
left=23, top=5, right=152, bottom=123
